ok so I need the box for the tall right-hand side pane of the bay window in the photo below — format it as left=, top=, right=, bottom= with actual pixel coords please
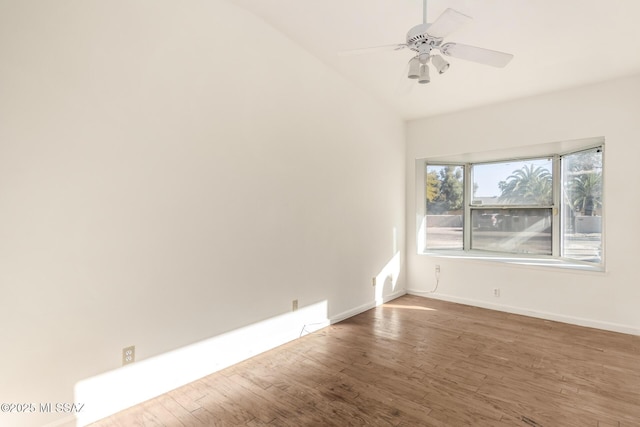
left=562, top=149, right=602, bottom=263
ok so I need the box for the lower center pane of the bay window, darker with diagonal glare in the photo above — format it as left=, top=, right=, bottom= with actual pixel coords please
left=471, top=208, right=552, bottom=255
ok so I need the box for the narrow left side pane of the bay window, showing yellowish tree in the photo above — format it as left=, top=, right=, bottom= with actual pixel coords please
left=425, top=165, right=464, bottom=249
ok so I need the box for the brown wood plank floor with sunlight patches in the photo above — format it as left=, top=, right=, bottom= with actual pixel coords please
left=93, top=295, right=640, bottom=427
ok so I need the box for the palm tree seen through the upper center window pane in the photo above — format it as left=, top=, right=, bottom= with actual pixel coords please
left=498, top=164, right=553, bottom=205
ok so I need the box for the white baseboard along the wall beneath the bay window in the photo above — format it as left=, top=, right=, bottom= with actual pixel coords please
left=407, top=289, right=640, bottom=335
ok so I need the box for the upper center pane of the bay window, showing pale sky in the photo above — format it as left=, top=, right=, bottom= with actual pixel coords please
left=471, top=159, right=553, bottom=206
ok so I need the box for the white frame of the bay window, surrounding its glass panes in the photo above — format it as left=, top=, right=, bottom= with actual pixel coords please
left=416, top=137, right=606, bottom=271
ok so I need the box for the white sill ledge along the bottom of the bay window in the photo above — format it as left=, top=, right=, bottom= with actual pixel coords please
left=418, top=250, right=605, bottom=272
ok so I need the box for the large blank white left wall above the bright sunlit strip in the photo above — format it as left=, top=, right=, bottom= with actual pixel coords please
left=0, top=0, right=405, bottom=426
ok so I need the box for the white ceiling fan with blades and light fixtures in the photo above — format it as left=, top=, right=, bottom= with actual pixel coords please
left=341, top=0, right=513, bottom=84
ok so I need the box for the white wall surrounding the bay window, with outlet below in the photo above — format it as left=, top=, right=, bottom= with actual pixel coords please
left=407, top=76, right=640, bottom=334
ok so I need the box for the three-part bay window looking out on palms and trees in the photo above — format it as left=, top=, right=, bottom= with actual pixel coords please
left=417, top=141, right=603, bottom=266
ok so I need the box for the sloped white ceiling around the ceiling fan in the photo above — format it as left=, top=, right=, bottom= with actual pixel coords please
left=230, top=0, right=640, bottom=119
